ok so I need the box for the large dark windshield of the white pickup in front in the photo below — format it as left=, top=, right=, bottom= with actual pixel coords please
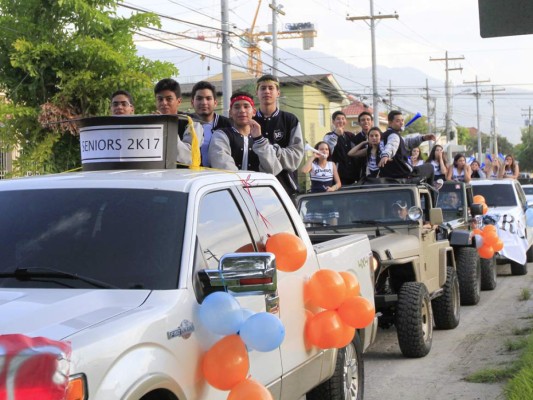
left=0, top=189, right=187, bottom=289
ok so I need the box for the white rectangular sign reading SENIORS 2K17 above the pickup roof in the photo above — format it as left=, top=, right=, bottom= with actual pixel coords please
left=80, top=125, right=164, bottom=164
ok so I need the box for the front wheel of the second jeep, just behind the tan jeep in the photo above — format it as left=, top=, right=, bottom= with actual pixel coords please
left=453, top=247, right=481, bottom=306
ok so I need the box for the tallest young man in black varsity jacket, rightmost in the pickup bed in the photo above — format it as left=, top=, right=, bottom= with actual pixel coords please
left=253, top=75, right=304, bottom=195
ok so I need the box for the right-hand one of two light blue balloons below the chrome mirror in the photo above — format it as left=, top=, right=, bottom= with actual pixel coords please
left=239, top=312, right=285, bottom=352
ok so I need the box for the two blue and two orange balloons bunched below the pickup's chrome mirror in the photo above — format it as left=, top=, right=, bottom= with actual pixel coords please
left=198, top=292, right=285, bottom=400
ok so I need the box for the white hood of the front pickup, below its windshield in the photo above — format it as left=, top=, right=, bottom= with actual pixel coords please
left=0, top=289, right=150, bottom=340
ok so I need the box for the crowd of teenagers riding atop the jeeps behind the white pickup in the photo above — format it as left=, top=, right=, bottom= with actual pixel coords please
left=301, top=111, right=519, bottom=192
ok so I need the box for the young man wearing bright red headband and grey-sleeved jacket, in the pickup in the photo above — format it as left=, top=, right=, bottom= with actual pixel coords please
left=209, top=92, right=272, bottom=172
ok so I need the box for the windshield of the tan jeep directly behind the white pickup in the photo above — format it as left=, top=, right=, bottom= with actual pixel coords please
left=299, top=190, right=415, bottom=229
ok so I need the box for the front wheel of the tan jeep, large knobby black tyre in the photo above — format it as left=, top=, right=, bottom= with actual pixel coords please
left=395, top=282, right=433, bottom=358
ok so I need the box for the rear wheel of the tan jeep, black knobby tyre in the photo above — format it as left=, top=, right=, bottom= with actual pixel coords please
left=431, top=267, right=461, bottom=329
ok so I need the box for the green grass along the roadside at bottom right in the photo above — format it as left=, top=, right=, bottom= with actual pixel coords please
left=465, top=289, right=533, bottom=400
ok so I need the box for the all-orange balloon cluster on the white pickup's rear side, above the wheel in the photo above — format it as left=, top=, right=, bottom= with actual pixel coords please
left=304, top=269, right=375, bottom=349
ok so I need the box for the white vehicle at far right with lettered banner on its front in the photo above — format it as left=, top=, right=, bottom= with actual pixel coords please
left=471, top=179, right=533, bottom=275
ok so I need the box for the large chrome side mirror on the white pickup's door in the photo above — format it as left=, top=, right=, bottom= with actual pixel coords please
left=198, top=253, right=277, bottom=294
